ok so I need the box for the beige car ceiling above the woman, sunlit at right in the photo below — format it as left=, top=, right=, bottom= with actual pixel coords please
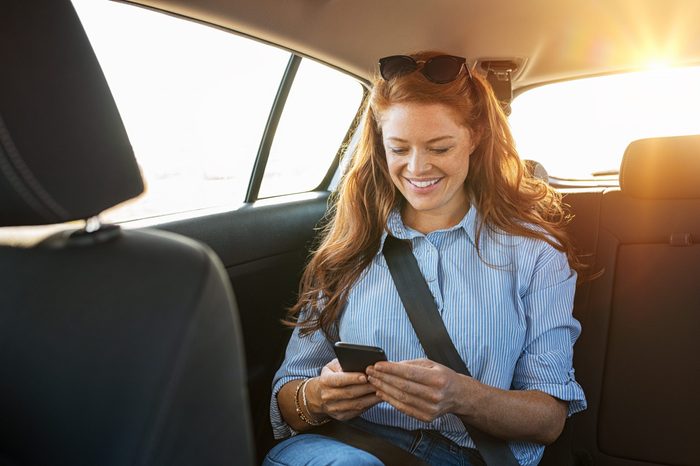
left=128, top=0, right=700, bottom=89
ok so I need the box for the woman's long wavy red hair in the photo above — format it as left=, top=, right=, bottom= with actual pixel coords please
left=287, top=52, right=583, bottom=339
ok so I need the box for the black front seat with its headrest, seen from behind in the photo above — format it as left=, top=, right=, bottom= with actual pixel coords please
left=0, top=0, right=254, bottom=466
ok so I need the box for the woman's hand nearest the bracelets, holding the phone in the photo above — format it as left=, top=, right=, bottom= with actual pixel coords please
left=306, top=359, right=381, bottom=421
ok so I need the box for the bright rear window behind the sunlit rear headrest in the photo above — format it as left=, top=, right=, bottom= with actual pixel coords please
left=510, top=67, right=700, bottom=179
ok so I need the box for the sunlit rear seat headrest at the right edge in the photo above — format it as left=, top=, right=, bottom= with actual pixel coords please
left=620, top=135, right=700, bottom=199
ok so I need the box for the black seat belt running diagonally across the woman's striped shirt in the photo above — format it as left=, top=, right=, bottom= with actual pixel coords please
left=382, top=235, right=520, bottom=466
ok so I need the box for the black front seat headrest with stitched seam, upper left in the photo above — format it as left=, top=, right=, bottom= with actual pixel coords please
left=0, top=0, right=143, bottom=226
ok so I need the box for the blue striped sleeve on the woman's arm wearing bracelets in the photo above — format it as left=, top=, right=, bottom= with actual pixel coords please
left=270, top=322, right=335, bottom=439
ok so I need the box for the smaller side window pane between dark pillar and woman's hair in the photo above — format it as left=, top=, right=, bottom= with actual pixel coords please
left=259, top=59, right=363, bottom=198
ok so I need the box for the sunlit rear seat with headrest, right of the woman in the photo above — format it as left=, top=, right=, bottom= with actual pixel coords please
left=572, top=135, right=700, bottom=466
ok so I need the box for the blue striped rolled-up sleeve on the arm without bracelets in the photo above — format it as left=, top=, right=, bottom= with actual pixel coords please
left=513, top=246, right=586, bottom=416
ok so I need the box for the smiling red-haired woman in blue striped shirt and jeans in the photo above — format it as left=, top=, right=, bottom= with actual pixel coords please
left=267, top=52, right=585, bottom=465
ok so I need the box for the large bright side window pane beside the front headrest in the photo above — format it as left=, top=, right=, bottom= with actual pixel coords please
left=73, top=0, right=290, bottom=221
